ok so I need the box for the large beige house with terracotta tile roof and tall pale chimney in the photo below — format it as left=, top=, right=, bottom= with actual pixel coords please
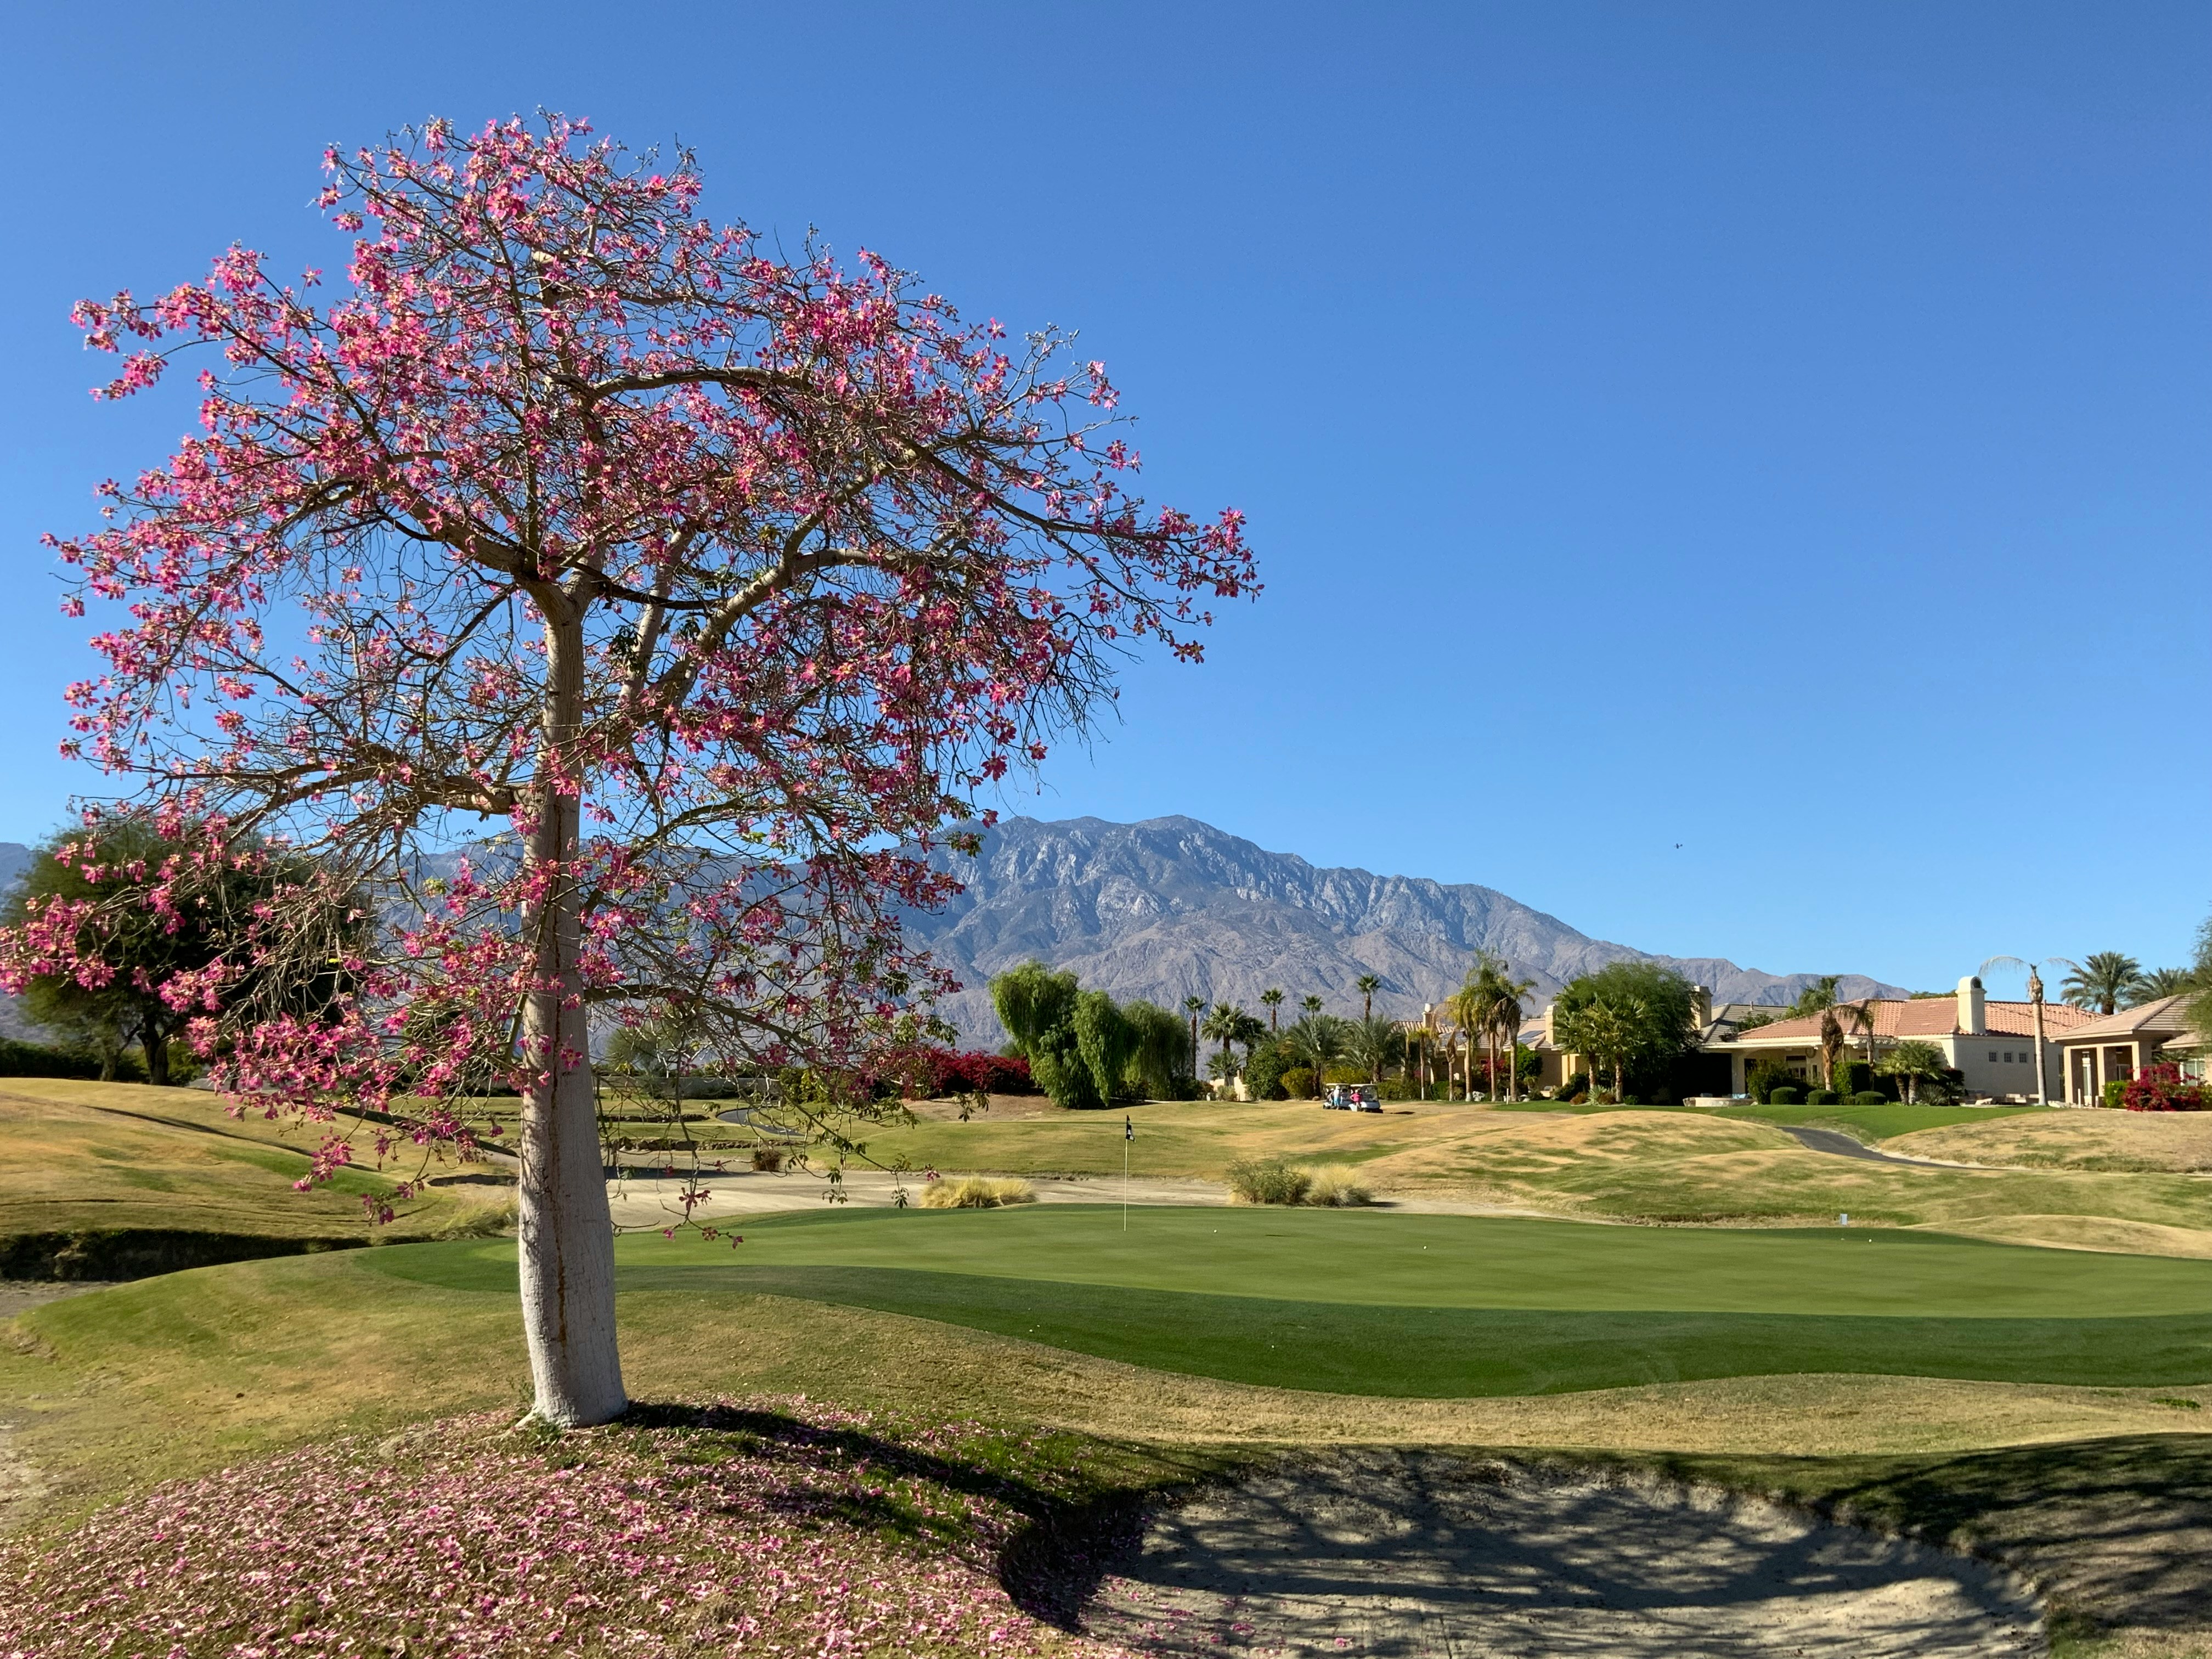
left=1703, top=973, right=2097, bottom=1099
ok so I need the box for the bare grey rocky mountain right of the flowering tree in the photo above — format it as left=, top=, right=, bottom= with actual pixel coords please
left=907, top=819, right=1907, bottom=1048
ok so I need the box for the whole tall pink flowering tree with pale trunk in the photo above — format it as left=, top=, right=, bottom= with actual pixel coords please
left=0, top=117, right=1254, bottom=1425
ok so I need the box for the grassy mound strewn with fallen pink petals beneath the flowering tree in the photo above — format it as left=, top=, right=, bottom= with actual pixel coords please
left=0, top=1400, right=1117, bottom=1659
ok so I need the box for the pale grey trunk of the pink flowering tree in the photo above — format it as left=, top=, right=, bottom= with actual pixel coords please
left=520, top=617, right=628, bottom=1429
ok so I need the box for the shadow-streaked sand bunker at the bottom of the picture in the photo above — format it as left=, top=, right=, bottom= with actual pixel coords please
left=1084, top=1451, right=2046, bottom=1659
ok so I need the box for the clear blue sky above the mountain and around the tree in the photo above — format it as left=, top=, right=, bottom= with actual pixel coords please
left=0, top=0, right=2212, bottom=1000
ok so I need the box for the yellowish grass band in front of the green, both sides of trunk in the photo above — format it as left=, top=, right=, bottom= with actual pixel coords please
left=0, top=1234, right=2212, bottom=1524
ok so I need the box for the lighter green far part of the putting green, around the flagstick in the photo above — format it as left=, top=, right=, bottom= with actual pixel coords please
left=371, top=1205, right=2212, bottom=1318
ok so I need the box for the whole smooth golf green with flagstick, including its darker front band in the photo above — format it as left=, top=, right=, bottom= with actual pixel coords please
left=367, top=1205, right=2212, bottom=1398
